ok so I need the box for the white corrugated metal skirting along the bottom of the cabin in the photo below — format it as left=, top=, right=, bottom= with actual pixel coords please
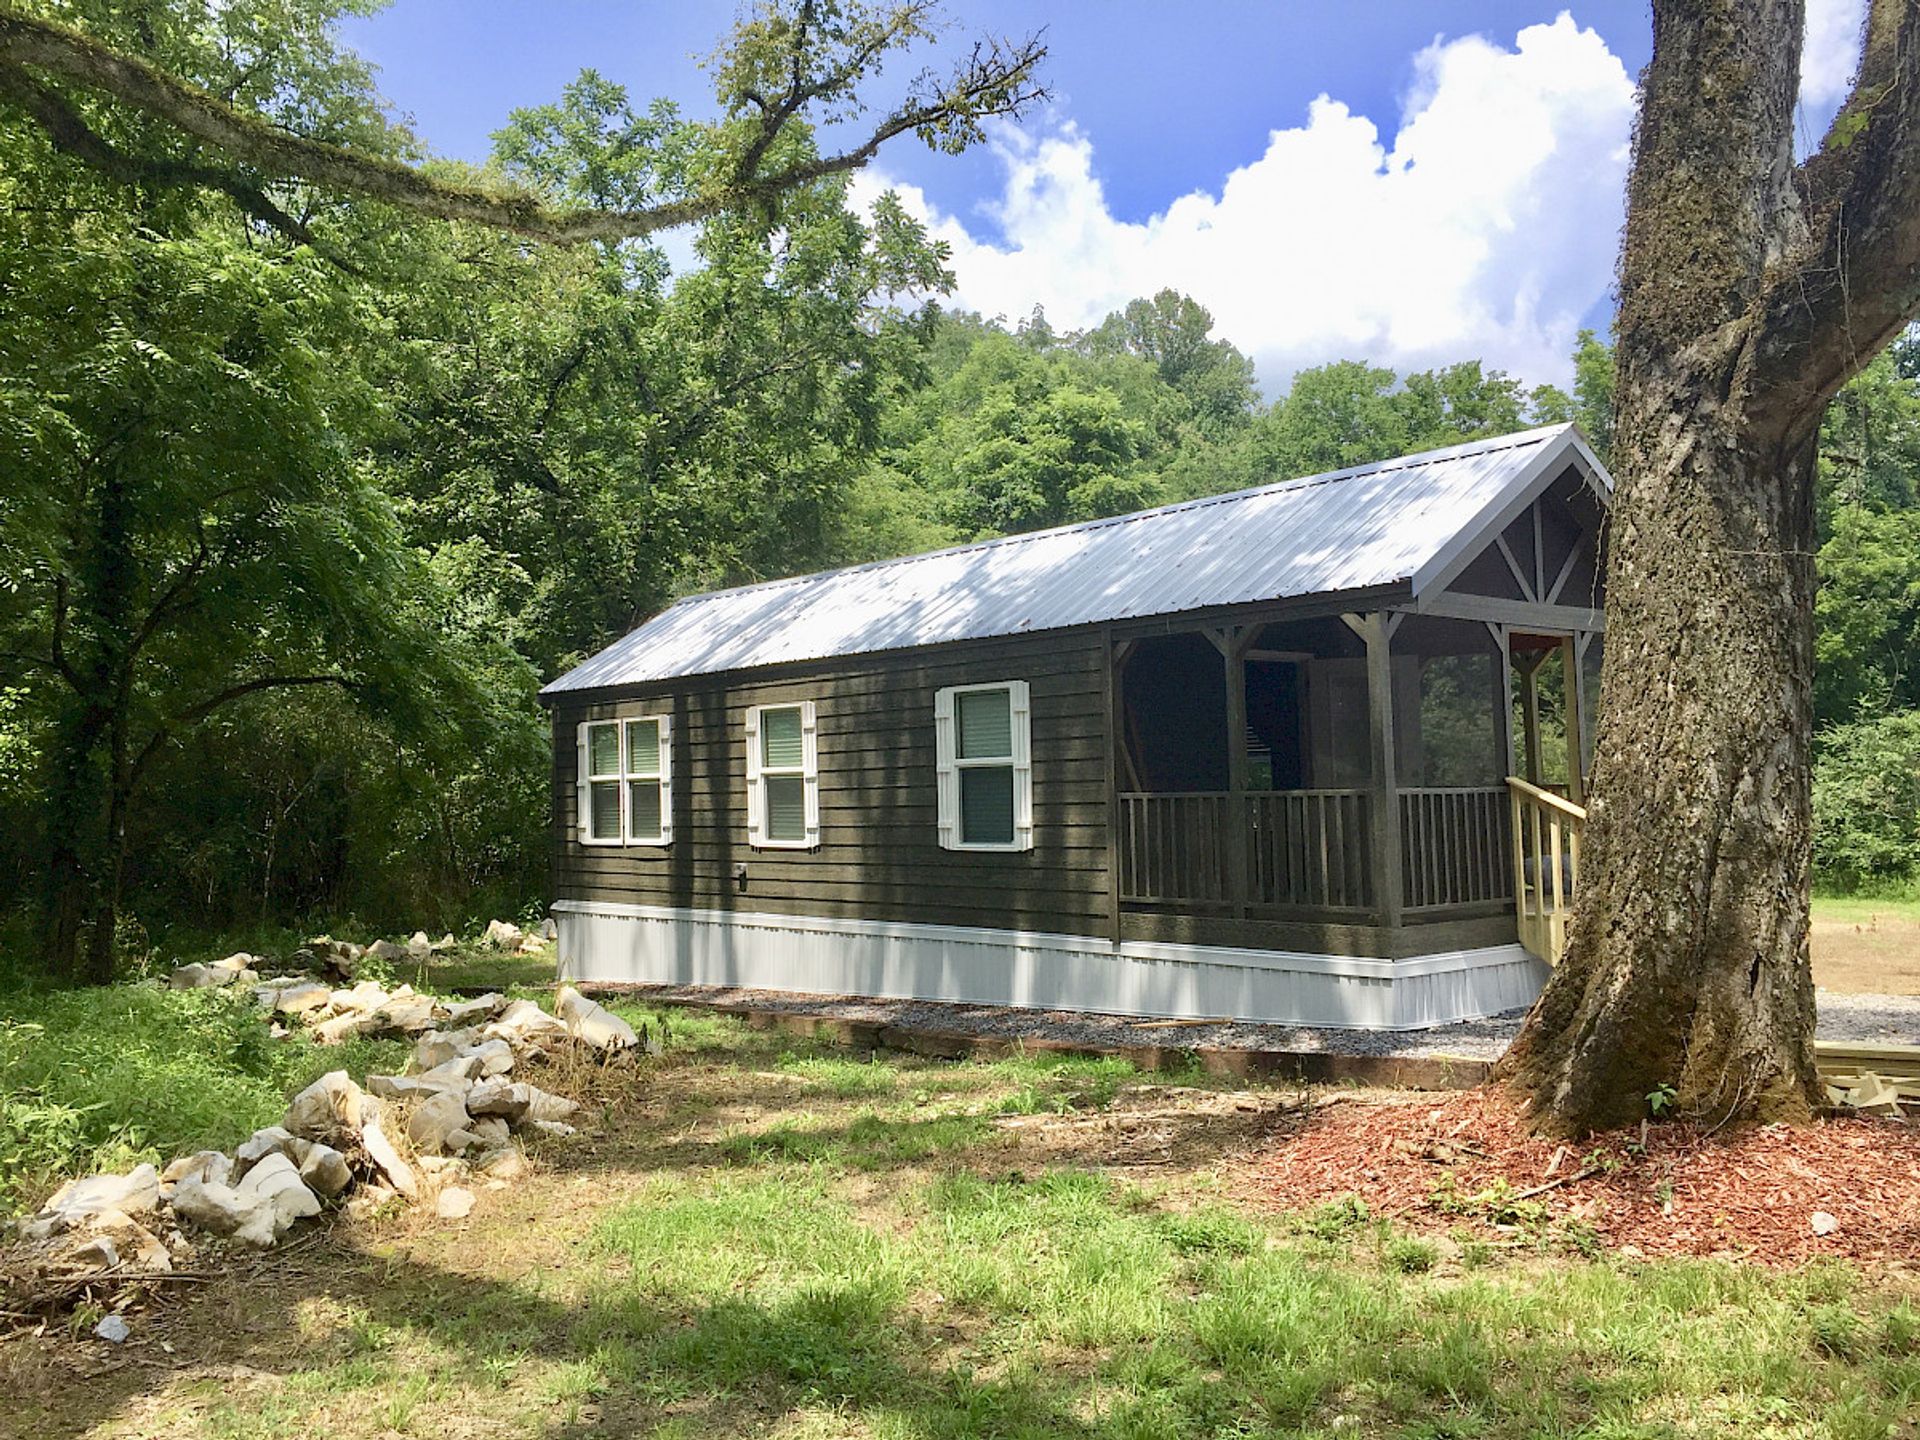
left=553, top=900, right=1548, bottom=1029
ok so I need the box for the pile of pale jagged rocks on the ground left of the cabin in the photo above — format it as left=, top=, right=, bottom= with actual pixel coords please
left=6, top=963, right=647, bottom=1328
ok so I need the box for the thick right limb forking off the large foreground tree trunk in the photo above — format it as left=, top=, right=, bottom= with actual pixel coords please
left=1749, top=0, right=1920, bottom=428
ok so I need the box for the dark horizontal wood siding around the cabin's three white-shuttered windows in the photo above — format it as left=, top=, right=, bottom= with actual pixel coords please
left=553, top=632, right=1110, bottom=935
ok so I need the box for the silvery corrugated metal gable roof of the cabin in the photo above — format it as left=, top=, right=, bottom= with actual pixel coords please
left=541, top=424, right=1609, bottom=695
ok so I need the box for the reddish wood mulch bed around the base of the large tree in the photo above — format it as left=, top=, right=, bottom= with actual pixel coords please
left=1252, top=1089, right=1920, bottom=1265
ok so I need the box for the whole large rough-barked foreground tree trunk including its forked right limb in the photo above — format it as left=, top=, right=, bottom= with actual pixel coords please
left=1503, top=0, right=1920, bottom=1133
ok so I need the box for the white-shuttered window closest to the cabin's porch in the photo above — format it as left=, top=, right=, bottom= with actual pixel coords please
left=933, top=680, right=1033, bottom=851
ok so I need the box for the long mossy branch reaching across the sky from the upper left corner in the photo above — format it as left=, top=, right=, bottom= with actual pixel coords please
left=0, top=10, right=1046, bottom=244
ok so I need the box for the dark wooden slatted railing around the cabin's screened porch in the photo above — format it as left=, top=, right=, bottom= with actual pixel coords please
left=1117, top=785, right=1513, bottom=916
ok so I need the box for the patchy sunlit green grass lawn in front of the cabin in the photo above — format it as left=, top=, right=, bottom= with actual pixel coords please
left=0, top=1016, right=1920, bottom=1440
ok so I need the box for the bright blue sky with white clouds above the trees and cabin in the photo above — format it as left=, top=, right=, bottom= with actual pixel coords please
left=346, top=0, right=1862, bottom=390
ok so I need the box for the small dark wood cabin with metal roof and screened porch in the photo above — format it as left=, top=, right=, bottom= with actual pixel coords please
left=541, top=426, right=1611, bottom=1029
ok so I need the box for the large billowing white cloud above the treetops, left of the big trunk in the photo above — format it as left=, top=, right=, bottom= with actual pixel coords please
left=860, top=15, right=1634, bottom=390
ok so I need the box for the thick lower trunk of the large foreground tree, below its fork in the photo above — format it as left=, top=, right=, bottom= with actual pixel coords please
left=1509, top=403, right=1814, bottom=1131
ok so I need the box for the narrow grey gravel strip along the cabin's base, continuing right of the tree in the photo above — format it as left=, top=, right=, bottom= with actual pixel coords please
left=628, top=985, right=1920, bottom=1060
